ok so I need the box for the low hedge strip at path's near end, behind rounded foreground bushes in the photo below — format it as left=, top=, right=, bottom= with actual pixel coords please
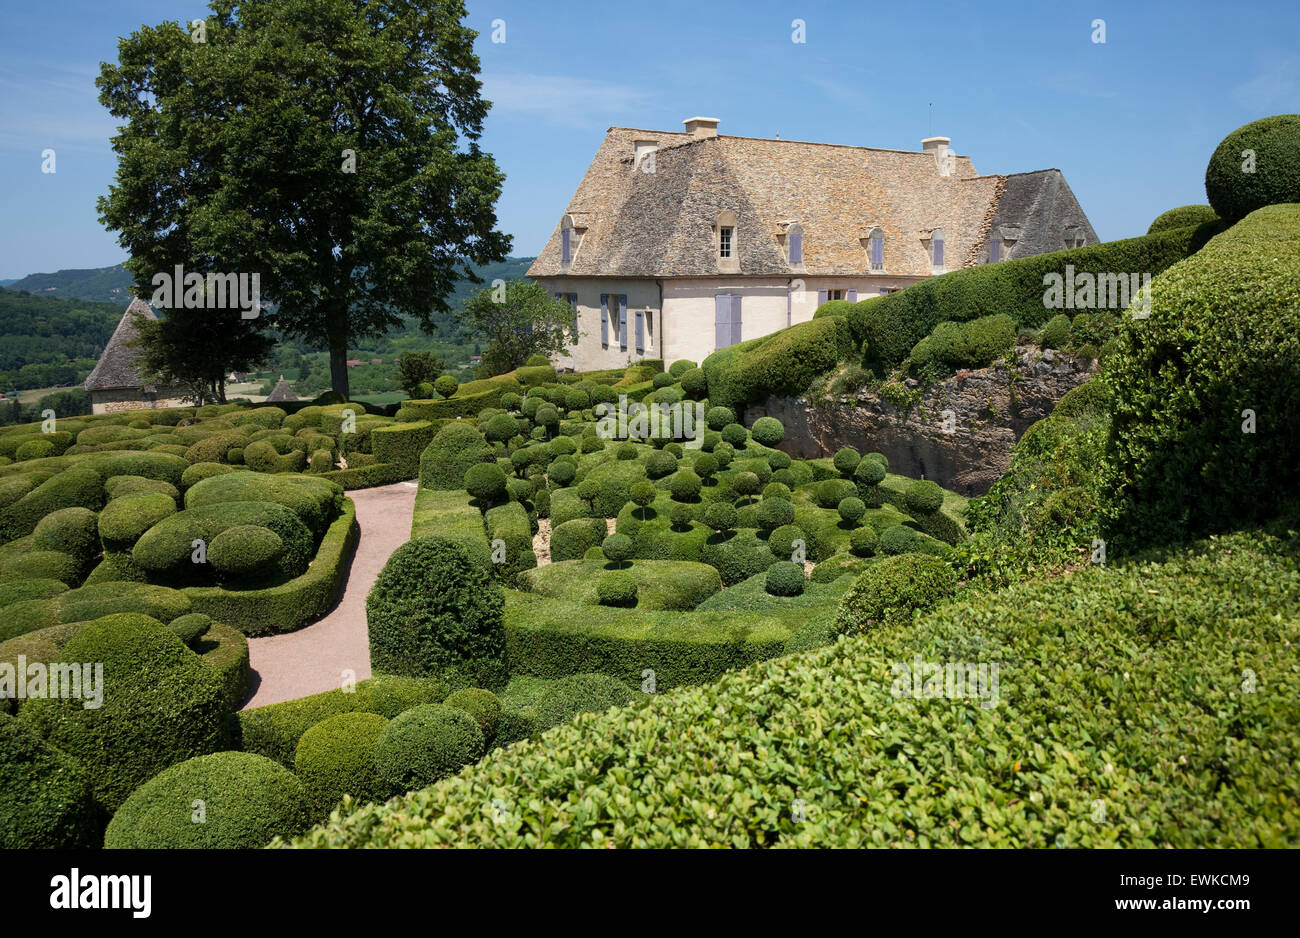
left=239, top=674, right=451, bottom=769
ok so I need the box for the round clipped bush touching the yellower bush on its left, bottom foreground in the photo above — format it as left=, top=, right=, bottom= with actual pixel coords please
left=374, top=704, right=485, bottom=791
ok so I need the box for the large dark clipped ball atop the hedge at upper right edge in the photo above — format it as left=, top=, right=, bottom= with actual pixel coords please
left=1205, top=114, right=1300, bottom=222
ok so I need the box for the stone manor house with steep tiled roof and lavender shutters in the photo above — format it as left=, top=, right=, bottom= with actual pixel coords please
left=528, top=117, right=1097, bottom=370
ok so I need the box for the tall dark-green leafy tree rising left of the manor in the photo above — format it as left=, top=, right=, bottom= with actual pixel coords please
left=98, top=0, right=510, bottom=395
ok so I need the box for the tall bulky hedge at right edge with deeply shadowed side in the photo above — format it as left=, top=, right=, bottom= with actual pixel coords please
left=1101, top=205, right=1300, bottom=551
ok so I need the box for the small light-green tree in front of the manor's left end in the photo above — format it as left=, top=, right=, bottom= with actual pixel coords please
left=456, top=281, right=576, bottom=377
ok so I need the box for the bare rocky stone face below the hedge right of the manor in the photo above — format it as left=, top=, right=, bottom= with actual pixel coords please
left=745, top=348, right=1096, bottom=495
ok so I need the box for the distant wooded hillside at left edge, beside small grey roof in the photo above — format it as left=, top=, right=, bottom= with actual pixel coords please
left=0, top=288, right=125, bottom=391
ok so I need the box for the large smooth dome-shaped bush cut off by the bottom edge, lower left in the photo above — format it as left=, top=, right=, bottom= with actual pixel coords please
left=104, top=752, right=312, bottom=850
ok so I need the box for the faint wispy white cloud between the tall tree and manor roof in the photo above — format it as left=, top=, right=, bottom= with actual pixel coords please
left=482, top=73, right=651, bottom=127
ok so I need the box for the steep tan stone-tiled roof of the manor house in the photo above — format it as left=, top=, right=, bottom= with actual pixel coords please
left=528, top=127, right=1096, bottom=277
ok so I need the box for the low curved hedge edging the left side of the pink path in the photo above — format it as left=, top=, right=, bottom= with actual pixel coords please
left=183, top=499, right=360, bottom=635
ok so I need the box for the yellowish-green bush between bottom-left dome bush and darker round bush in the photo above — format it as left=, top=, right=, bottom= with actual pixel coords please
left=294, top=713, right=397, bottom=818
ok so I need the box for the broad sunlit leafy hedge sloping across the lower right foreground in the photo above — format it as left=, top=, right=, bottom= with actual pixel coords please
left=295, top=524, right=1300, bottom=848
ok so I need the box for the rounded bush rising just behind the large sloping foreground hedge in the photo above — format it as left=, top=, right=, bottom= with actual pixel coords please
left=835, top=553, right=957, bottom=635
